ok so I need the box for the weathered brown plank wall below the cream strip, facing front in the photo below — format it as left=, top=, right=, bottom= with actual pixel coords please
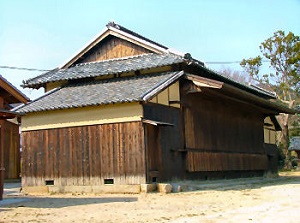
left=22, top=122, right=145, bottom=186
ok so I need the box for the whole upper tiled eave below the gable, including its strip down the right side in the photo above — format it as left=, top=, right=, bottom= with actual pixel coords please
left=23, top=50, right=275, bottom=102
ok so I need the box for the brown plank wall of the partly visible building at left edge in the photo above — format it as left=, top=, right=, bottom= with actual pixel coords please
left=0, top=120, right=20, bottom=179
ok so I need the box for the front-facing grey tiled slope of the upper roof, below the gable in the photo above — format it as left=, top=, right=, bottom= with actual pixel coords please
left=23, top=53, right=185, bottom=88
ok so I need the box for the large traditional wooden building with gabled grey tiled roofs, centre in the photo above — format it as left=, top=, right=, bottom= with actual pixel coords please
left=17, top=23, right=293, bottom=191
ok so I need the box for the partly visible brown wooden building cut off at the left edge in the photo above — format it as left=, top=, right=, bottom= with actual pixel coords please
left=0, top=75, right=29, bottom=199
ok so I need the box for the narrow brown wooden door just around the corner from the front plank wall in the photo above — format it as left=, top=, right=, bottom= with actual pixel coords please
left=145, top=124, right=162, bottom=183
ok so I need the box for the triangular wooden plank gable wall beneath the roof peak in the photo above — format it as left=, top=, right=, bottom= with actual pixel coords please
left=76, top=37, right=151, bottom=63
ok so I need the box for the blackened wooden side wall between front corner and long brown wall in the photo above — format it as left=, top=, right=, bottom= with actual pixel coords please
left=144, top=103, right=185, bottom=183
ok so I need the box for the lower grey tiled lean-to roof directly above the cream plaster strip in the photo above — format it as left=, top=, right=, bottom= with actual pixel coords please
left=15, top=72, right=184, bottom=113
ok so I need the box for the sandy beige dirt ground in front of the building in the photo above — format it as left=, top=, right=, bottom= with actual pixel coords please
left=0, top=172, right=300, bottom=223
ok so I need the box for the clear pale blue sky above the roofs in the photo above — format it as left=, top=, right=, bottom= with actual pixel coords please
left=0, top=0, right=300, bottom=99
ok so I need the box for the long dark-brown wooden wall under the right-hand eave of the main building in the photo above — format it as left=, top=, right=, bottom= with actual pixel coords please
left=183, top=93, right=268, bottom=172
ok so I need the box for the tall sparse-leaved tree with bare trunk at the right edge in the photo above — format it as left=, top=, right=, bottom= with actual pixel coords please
left=240, top=31, right=300, bottom=168
